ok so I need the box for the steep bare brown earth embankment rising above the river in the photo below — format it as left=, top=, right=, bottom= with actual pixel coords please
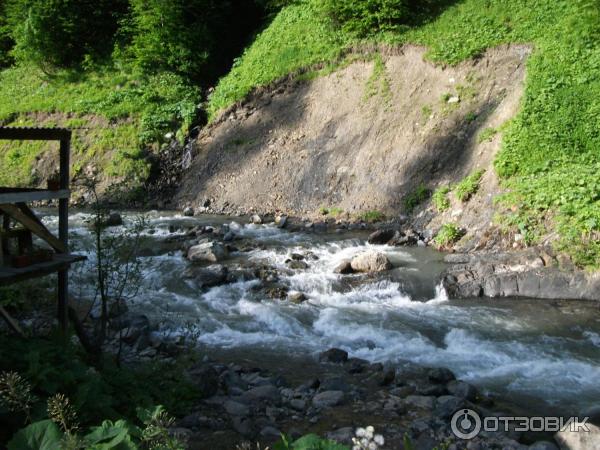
left=178, top=46, right=529, bottom=248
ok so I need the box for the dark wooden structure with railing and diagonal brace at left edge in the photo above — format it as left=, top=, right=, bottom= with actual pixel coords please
left=0, top=127, right=84, bottom=332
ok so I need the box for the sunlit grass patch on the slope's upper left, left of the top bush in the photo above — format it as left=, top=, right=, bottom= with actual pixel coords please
left=208, top=1, right=348, bottom=118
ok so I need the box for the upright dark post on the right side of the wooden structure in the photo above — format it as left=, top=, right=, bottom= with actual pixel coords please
left=57, top=136, right=71, bottom=335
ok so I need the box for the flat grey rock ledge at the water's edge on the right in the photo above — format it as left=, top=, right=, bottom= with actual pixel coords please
left=443, top=249, right=600, bottom=301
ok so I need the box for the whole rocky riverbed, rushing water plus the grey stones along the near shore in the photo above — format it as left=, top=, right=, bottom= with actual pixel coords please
left=31, top=212, right=600, bottom=448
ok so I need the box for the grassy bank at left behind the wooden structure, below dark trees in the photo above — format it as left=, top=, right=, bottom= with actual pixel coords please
left=0, top=66, right=199, bottom=190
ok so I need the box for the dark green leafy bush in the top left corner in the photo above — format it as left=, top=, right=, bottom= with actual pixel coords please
left=6, top=0, right=128, bottom=70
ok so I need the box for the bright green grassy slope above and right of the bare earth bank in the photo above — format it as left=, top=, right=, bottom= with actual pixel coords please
left=208, top=0, right=600, bottom=267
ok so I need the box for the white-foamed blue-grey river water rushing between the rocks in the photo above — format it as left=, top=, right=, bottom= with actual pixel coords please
left=44, top=212, right=600, bottom=414
